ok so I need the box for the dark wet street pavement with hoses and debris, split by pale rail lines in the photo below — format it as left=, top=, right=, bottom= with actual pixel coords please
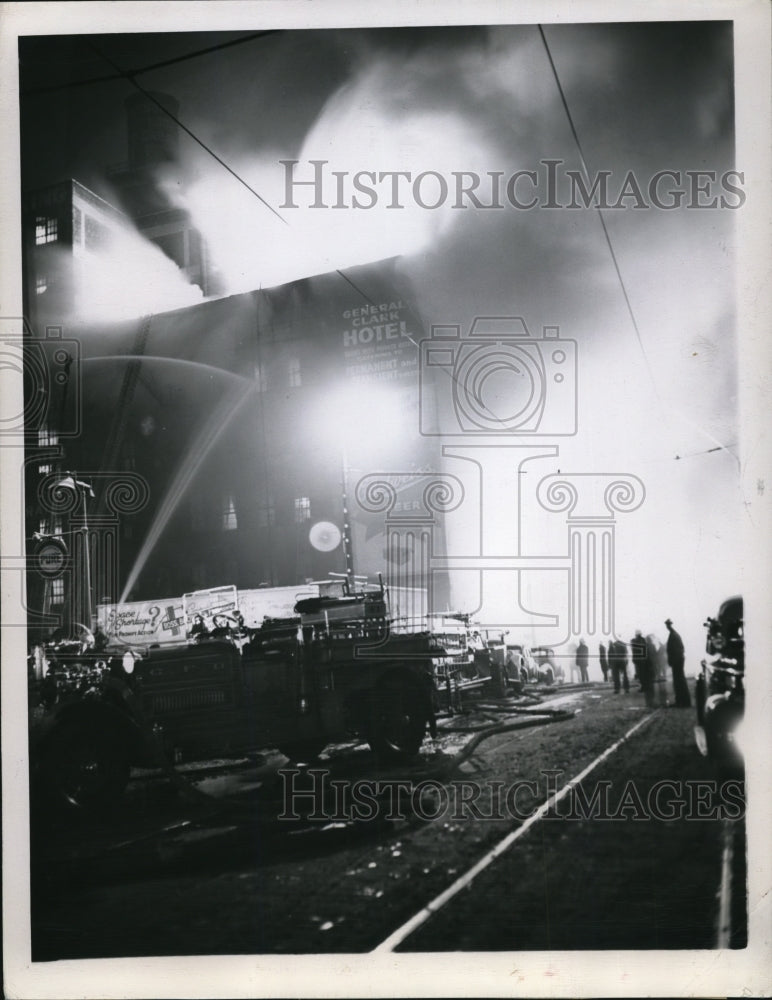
left=27, top=685, right=744, bottom=961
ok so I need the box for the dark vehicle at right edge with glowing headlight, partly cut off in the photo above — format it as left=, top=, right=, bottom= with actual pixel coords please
left=695, top=596, right=745, bottom=770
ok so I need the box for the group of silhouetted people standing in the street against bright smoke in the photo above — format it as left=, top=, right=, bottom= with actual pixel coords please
left=576, top=618, right=691, bottom=708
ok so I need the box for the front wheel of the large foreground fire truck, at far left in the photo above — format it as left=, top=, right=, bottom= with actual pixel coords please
left=43, top=723, right=130, bottom=809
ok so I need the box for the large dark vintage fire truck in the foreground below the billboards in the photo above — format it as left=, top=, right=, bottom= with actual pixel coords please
left=30, top=581, right=445, bottom=806
